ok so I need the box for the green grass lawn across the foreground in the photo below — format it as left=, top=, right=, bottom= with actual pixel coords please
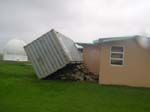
left=0, top=62, right=150, bottom=112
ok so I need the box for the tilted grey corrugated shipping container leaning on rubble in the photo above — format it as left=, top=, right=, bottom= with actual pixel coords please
left=24, top=30, right=82, bottom=78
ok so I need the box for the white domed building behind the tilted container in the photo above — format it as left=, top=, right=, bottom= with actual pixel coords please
left=3, top=39, right=28, bottom=61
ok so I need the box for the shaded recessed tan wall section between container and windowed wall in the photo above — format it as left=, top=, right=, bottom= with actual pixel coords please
left=83, top=46, right=100, bottom=75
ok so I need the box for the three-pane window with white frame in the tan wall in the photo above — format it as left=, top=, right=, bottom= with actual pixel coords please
left=110, top=46, right=124, bottom=65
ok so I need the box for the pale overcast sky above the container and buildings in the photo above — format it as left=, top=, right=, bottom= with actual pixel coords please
left=0, top=0, right=150, bottom=51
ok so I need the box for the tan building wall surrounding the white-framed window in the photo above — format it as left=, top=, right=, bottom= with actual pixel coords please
left=99, top=40, right=150, bottom=87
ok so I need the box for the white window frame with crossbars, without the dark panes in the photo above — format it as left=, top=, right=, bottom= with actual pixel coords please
left=110, top=45, right=125, bottom=66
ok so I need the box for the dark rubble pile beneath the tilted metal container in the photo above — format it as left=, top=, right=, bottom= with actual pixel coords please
left=46, top=64, right=98, bottom=82
